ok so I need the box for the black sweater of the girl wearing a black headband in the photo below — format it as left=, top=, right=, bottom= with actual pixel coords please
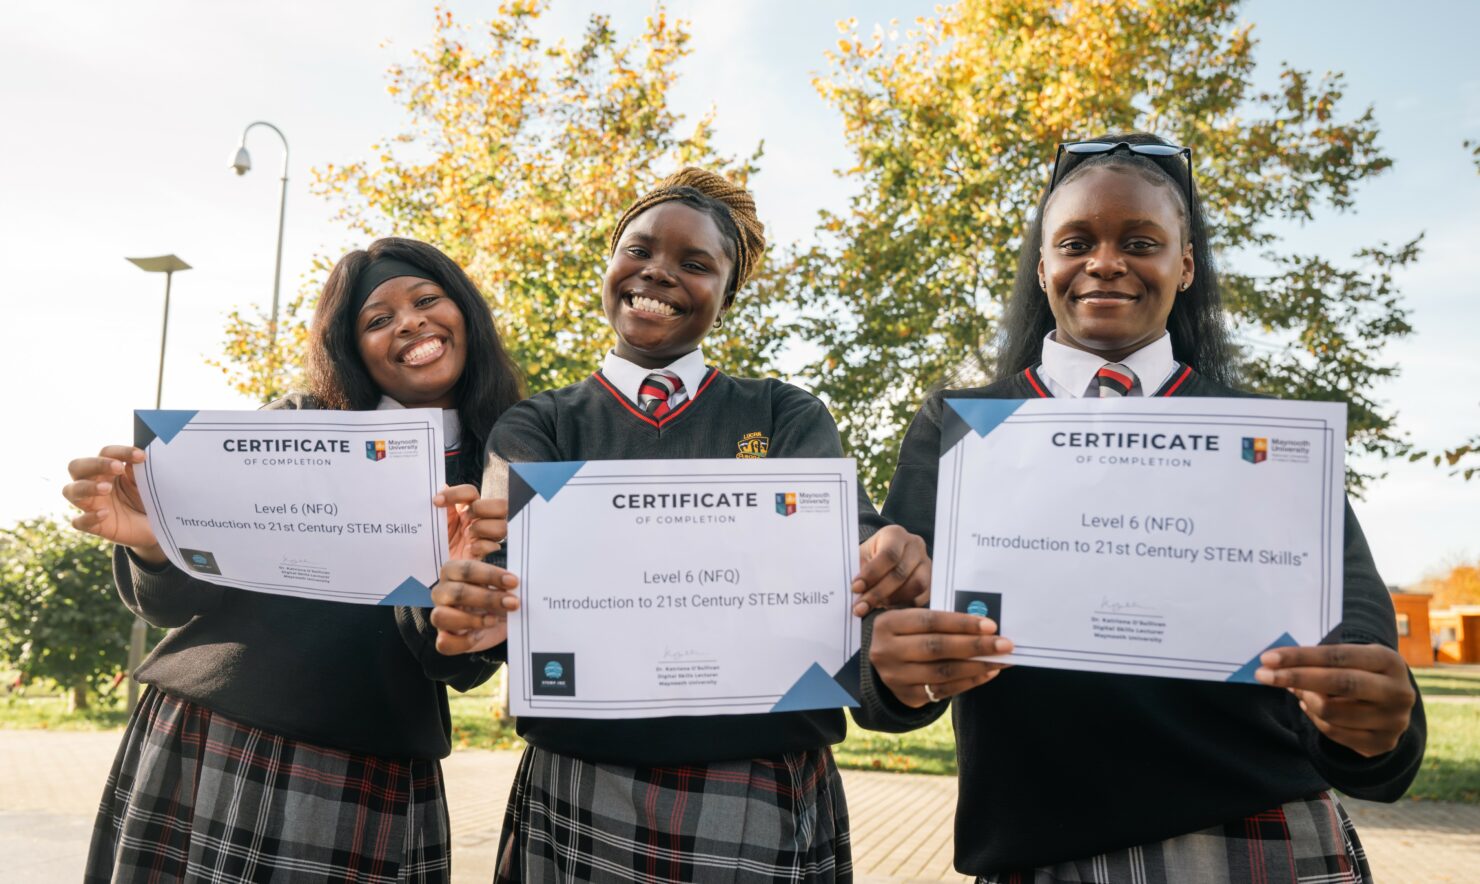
left=112, top=395, right=496, bottom=758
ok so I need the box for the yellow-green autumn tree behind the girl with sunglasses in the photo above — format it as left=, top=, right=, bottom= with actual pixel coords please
left=790, top=0, right=1418, bottom=493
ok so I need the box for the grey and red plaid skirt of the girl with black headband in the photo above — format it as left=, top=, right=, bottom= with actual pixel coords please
left=84, top=689, right=451, bottom=884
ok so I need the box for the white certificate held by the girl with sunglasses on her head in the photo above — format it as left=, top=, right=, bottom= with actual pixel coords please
left=931, top=398, right=1347, bottom=681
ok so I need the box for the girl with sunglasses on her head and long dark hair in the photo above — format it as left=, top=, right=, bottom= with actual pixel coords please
left=864, top=135, right=1425, bottom=883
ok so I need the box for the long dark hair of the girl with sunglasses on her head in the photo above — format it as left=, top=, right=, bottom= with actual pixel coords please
left=998, top=132, right=1234, bottom=384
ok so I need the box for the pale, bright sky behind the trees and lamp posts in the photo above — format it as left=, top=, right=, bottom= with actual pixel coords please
left=0, top=0, right=1480, bottom=583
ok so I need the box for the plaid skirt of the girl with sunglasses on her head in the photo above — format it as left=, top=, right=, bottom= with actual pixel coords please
left=977, top=792, right=1372, bottom=884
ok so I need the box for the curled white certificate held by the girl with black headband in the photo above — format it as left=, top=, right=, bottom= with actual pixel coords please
left=135, top=409, right=447, bottom=607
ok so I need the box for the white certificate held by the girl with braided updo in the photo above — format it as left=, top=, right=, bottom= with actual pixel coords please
left=508, top=459, right=860, bottom=718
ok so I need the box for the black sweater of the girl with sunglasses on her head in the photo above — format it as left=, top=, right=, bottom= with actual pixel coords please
left=857, top=366, right=1425, bottom=875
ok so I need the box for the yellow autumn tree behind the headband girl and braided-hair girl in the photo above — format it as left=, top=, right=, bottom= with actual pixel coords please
left=226, top=0, right=781, bottom=397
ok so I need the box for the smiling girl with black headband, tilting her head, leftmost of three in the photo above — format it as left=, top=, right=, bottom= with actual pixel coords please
left=64, top=238, right=521, bottom=883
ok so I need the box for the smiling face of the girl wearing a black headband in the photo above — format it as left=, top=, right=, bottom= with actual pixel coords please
left=355, top=277, right=468, bottom=409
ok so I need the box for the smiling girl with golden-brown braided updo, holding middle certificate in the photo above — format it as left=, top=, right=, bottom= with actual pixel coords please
left=432, top=169, right=928, bottom=883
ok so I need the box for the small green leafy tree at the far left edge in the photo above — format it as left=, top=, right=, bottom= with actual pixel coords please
left=0, top=518, right=133, bottom=709
